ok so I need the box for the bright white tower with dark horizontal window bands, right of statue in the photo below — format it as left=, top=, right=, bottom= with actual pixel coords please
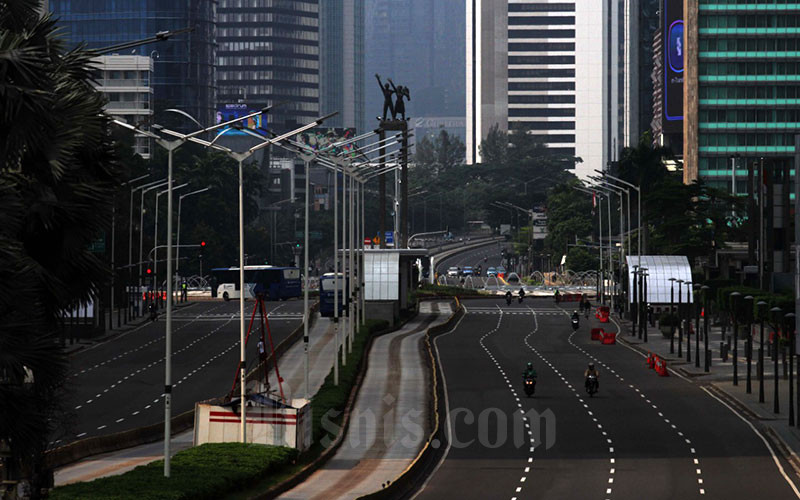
left=466, top=0, right=640, bottom=177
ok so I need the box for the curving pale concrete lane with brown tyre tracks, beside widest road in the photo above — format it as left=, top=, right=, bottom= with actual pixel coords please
left=280, top=301, right=452, bottom=500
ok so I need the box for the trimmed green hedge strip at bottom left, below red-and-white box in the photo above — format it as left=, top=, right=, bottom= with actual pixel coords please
left=49, top=443, right=297, bottom=500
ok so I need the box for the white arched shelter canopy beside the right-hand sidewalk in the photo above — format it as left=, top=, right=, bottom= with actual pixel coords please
left=626, top=255, right=693, bottom=304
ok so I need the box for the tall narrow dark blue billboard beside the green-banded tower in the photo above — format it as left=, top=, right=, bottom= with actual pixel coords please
left=661, top=0, right=684, bottom=132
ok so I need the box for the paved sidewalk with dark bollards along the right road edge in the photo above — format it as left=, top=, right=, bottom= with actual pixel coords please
left=620, top=317, right=800, bottom=469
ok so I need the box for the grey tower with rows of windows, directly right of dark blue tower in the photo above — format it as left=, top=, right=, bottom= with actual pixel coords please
left=217, top=0, right=320, bottom=133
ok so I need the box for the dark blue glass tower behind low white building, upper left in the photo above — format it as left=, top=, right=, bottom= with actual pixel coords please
left=50, top=0, right=216, bottom=124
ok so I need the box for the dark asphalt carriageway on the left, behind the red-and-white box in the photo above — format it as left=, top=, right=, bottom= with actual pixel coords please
left=54, top=300, right=303, bottom=445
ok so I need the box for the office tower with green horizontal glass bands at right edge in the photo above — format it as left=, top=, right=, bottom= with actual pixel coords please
left=680, top=0, right=800, bottom=188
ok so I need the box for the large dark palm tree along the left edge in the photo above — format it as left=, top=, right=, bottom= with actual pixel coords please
left=0, top=0, right=120, bottom=496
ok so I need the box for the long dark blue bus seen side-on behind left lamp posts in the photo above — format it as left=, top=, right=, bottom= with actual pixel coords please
left=211, top=266, right=303, bottom=301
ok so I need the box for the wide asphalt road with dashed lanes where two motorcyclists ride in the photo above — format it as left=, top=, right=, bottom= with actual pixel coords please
left=417, top=299, right=800, bottom=499
